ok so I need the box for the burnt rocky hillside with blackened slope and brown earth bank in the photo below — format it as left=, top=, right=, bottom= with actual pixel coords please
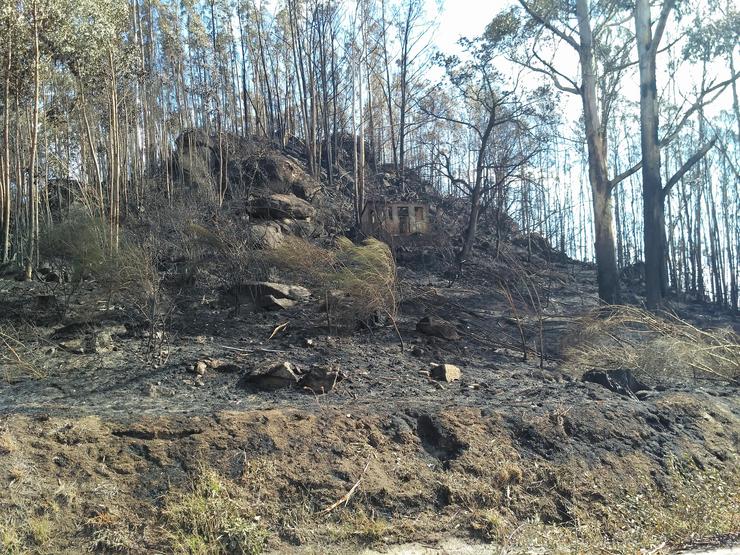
left=0, top=134, right=740, bottom=553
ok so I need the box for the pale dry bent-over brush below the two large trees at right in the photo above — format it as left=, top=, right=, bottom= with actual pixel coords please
left=565, top=306, right=740, bottom=384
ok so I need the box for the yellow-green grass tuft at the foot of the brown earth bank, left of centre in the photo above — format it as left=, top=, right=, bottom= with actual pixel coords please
left=164, top=470, right=267, bottom=555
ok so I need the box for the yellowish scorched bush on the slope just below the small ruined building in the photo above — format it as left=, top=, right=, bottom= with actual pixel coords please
left=268, top=237, right=398, bottom=327
